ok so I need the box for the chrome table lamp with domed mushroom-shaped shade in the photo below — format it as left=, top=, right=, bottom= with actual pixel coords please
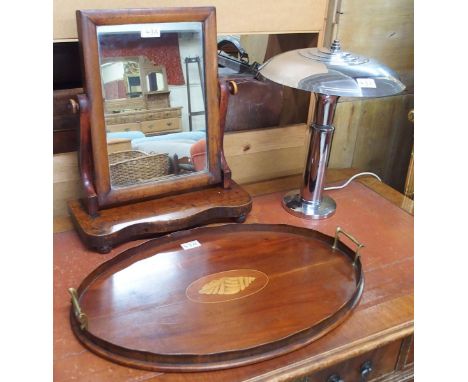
left=259, top=40, right=405, bottom=219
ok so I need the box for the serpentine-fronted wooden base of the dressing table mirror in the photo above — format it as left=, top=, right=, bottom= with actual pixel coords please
left=68, top=181, right=252, bottom=253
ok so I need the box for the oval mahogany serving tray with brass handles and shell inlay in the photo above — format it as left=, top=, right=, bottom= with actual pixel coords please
left=70, top=224, right=364, bottom=371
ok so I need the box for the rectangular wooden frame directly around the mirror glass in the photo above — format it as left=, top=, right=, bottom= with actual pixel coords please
left=77, top=7, right=222, bottom=209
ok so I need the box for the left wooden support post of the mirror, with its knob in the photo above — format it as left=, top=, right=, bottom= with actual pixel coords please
left=70, top=94, right=98, bottom=216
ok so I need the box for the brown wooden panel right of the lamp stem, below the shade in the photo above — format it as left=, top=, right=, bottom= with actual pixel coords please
left=329, top=94, right=414, bottom=192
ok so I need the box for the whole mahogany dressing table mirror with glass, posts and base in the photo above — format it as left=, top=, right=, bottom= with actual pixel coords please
left=69, top=7, right=252, bottom=253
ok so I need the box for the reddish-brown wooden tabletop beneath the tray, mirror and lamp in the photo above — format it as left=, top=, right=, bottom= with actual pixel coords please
left=54, top=170, right=413, bottom=381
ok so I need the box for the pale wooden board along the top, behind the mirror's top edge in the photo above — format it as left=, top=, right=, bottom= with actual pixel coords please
left=54, top=0, right=328, bottom=40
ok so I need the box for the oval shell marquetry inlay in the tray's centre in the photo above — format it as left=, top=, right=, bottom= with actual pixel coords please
left=186, top=269, right=268, bottom=303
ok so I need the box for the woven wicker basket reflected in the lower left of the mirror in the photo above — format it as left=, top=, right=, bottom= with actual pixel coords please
left=109, top=151, right=170, bottom=187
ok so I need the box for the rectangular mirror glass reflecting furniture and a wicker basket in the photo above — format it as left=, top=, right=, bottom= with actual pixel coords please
left=97, top=22, right=208, bottom=188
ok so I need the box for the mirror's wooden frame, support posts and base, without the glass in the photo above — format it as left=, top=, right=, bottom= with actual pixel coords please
left=68, top=7, right=252, bottom=253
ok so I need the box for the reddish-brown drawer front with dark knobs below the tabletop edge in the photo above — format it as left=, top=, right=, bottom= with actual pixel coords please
left=296, top=341, right=401, bottom=382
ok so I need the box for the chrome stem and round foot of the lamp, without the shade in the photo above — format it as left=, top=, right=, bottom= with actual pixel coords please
left=283, top=94, right=339, bottom=219
